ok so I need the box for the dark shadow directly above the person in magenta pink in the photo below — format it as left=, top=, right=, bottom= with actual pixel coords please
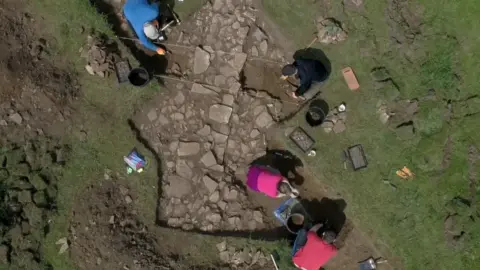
left=250, top=149, right=305, bottom=186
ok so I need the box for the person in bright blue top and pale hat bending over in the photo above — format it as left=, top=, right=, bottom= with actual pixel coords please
left=123, top=0, right=165, bottom=55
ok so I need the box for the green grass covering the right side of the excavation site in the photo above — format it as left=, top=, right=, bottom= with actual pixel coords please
left=264, top=0, right=480, bottom=269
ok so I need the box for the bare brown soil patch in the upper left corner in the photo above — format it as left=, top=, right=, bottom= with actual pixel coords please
left=0, top=1, right=79, bottom=143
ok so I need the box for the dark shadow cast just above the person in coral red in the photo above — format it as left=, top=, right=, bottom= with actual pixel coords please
left=300, top=198, right=347, bottom=234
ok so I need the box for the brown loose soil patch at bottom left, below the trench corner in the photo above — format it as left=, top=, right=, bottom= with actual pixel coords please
left=69, top=180, right=219, bottom=269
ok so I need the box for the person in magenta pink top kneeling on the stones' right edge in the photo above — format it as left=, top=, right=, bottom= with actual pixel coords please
left=247, top=165, right=299, bottom=198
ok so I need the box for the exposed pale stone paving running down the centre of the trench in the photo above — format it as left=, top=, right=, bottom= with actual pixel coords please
left=135, top=0, right=284, bottom=231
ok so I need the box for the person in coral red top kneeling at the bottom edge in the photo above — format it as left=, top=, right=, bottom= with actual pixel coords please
left=292, top=224, right=337, bottom=270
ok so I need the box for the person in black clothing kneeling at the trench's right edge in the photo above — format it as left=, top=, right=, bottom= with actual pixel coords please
left=281, top=59, right=328, bottom=100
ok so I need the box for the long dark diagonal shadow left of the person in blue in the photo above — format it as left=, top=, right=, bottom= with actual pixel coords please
left=89, top=0, right=174, bottom=85
